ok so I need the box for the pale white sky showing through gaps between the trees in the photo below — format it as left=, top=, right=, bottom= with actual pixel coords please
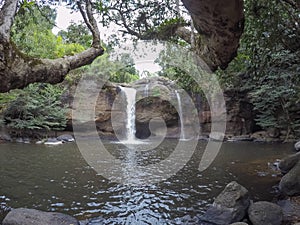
left=52, top=5, right=160, bottom=74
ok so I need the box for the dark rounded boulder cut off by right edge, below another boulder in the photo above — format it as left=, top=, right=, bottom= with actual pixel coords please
left=279, top=161, right=300, bottom=196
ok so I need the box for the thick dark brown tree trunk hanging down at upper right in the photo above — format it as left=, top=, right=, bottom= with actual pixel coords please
left=182, top=0, right=244, bottom=70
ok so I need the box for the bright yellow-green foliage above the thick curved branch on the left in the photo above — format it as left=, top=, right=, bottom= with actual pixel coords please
left=12, top=4, right=85, bottom=59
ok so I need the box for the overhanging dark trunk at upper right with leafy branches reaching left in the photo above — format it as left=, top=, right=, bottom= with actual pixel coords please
left=103, top=0, right=245, bottom=71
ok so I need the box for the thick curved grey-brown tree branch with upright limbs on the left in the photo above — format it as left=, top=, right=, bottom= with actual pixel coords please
left=0, top=0, right=104, bottom=92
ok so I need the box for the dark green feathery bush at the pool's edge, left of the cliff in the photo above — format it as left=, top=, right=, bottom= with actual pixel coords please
left=4, top=83, right=67, bottom=134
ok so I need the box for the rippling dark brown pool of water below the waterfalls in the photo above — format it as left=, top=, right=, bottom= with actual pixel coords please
left=0, top=140, right=293, bottom=225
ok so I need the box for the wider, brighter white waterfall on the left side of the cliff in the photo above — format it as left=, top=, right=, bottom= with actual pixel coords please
left=121, top=87, right=136, bottom=142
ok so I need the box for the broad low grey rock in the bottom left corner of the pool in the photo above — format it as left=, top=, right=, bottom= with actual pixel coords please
left=3, top=208, right=79, bottom=225
